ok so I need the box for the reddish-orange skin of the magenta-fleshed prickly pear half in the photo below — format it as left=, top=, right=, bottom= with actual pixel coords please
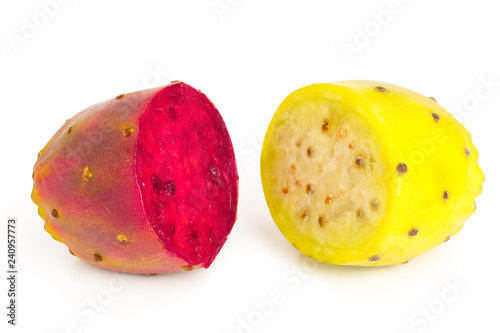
left=32, top=81, right=238, bottom=274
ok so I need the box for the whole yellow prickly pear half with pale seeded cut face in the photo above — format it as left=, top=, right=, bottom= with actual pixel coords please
left=261, top=81, right=484, bottom=266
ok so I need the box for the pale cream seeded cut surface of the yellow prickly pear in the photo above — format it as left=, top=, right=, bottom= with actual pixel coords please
left=267, top=98, right=388, bottom=251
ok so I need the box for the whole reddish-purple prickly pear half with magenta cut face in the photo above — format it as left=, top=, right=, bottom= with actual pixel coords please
left=32, top=82, right=238, bottom=274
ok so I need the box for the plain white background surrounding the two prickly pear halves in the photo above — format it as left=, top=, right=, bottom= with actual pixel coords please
left=0, top=0, right=500, bottom=333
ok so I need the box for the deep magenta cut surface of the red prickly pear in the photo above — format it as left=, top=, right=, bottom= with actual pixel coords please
left=136, top=85, right=237, bottom=267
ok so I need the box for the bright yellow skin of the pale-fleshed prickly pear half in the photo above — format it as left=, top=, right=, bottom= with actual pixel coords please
left=261, top=80, right=484, bottom=266
